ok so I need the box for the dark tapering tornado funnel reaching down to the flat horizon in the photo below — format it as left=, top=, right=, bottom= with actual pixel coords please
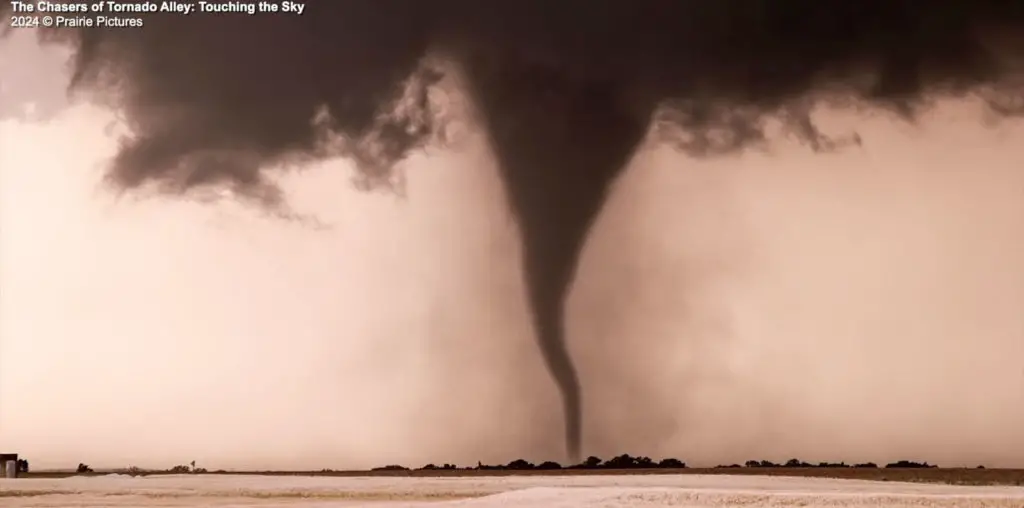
left=467, top=56, right=647, bottom=461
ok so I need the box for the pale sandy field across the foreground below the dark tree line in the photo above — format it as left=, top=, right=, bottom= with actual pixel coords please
left=0, top=474, right=1024, bottom=508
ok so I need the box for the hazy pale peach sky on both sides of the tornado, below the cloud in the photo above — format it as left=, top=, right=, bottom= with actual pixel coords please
left=0, top=30, right=1024, bottom=469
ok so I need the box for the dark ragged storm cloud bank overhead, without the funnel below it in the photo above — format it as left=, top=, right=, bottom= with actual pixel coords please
left=3, top=0, right=1024, bottom=202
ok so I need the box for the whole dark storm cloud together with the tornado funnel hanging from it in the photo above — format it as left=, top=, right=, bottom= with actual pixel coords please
left=0, top=0, right=1024, bottom=458
